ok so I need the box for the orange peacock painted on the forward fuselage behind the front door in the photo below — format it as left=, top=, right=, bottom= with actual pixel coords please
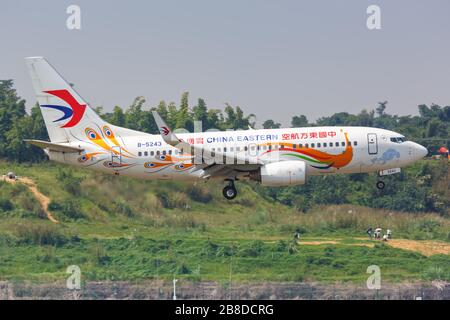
left=264, top=133, right=353, bottom=169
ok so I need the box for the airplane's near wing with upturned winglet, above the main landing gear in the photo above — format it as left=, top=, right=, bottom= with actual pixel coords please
left=152, top=111, right=263, bottom=178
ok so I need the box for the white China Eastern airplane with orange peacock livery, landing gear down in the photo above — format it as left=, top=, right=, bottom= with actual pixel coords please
left=26, top=57, right=428, bottom=200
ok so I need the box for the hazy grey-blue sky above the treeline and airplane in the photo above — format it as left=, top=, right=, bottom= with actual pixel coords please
left=0, top=0, right=450, bottom=125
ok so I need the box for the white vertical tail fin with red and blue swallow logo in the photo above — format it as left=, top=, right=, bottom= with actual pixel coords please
left=25, top=57, right=105, bottom=143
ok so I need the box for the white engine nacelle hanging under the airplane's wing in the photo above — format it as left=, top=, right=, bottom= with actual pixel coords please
left=250, top=161, right=306, bottom=187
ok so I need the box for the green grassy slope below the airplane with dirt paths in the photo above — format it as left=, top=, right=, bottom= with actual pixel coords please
left=0, top=162, right=450, bottom=283
